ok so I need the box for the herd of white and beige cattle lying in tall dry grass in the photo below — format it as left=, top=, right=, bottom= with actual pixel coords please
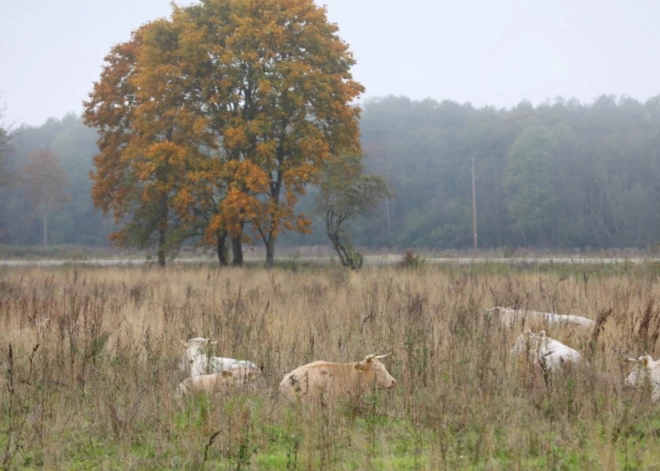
left=177, top=307, right=660, bottom=403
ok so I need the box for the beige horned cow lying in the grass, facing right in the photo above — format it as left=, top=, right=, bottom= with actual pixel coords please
left=280, top=354, right=396, bottom=403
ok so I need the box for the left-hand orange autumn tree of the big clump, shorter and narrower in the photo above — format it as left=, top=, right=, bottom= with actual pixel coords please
left=84, top=25, right=195, bottom=266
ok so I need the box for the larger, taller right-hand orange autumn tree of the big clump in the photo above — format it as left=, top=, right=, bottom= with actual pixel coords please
left=145, top=0, right=363, bottom=266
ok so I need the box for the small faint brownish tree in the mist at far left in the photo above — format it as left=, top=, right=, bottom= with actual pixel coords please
left=21, top=149, right=71, bottom=247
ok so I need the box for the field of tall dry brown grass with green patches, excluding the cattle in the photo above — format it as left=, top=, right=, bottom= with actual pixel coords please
left=0, top=263, right=660, bottom=470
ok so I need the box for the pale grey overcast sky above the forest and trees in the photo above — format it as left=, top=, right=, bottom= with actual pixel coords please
left=0, top=0, right=660, bottom=125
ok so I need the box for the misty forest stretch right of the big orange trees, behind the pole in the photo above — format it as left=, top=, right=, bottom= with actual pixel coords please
left=356, top=96, right=660, bottom=253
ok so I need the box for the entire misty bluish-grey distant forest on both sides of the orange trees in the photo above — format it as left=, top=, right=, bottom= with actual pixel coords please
left=0, top=96, right=660, bottom=253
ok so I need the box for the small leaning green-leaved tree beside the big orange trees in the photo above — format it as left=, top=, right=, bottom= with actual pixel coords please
left=316, top=157, right=393, bottom=270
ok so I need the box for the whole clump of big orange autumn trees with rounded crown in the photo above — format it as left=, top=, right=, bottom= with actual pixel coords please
left=85, top=0, right=363, bottom=265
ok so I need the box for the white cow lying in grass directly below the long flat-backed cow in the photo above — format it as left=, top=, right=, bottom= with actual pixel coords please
left=511, top=329, right=582, bottom=370
